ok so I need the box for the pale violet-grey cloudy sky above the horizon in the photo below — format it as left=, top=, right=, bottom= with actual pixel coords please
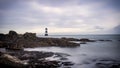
left=0, top=0, right=120, bottom=35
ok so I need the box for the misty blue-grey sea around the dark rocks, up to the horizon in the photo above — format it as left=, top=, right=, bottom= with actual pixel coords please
left=24, top=35, right=120, bottom=68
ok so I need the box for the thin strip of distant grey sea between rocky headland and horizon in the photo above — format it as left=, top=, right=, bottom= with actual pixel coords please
left=44, top=35, right=120, bottom=40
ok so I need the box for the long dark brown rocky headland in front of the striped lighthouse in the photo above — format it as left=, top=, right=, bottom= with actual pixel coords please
left=0, top=31, right=80, bottom=50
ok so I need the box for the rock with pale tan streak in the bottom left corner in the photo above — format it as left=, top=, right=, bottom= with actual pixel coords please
left=0, top=53, right=25, bottom=68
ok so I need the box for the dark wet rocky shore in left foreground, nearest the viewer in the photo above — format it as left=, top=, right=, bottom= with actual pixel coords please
left=0, top=51, right=74, bottom=68
